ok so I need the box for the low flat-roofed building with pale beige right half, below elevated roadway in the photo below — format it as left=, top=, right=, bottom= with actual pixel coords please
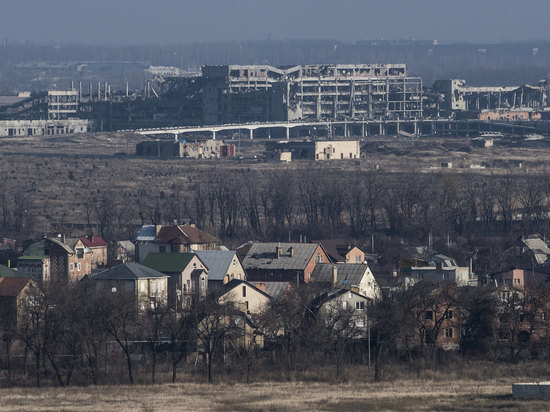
left=265, top=140, right=361, bottom=161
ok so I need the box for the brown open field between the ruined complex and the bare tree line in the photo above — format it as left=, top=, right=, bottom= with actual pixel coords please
left=0, top=133, right=550, bottom=241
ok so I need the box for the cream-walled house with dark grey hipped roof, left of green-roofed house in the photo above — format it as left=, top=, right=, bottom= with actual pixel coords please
left=89, top=262, right=169, bottom=311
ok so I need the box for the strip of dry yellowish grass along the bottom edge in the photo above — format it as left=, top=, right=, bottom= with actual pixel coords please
left=0, top=379, right=550, bottom=411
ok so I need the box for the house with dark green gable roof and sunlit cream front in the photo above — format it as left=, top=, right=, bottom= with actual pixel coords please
left=143, top=253, right=208, bottom=308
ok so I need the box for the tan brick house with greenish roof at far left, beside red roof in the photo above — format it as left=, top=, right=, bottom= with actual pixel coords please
left=23, top=237, right=92, bottom=283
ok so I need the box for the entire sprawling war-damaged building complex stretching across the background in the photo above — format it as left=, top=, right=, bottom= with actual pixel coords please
left=0, top=64, right=550, bottom=140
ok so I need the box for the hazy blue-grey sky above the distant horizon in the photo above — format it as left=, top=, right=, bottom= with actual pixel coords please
left=4, top=0, right=550, bottom=44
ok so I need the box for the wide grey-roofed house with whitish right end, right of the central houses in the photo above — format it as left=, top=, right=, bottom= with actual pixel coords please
left=399, top=254, right=477, bottom=286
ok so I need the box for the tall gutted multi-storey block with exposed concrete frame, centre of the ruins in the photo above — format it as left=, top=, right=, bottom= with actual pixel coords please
left=202, top=64, right=422, bottom=124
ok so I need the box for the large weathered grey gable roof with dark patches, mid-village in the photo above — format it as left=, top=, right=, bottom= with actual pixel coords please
left=242, top=242, right=319, bottom=270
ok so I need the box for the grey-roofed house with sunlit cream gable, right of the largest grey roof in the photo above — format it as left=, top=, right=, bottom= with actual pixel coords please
left=311, top=263, right=381, bottom=299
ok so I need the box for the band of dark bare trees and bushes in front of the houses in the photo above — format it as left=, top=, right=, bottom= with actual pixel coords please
left=0, top=279, right=550, bottom=386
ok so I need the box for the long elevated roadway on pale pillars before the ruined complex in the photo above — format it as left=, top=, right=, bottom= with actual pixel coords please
left=129, top=119, right=550, bottom=140
